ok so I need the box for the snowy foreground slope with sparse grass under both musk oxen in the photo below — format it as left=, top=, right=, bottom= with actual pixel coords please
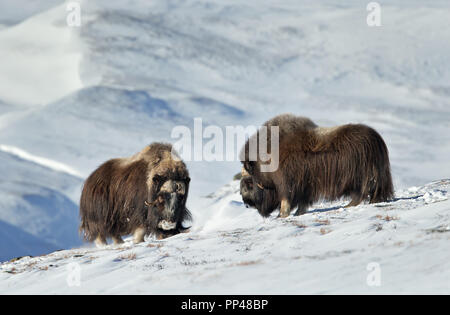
left=0, top=180, right=450, bottom=294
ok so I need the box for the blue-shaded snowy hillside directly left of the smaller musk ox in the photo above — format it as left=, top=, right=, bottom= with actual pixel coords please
left=0, top=146, right=82, bottom=260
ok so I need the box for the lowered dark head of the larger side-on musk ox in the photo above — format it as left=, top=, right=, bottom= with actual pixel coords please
left=240, top=169, right=280, bottom=217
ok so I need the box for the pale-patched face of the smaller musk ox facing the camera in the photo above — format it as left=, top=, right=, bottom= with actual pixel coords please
left=148, top=176, right=190, bottom=236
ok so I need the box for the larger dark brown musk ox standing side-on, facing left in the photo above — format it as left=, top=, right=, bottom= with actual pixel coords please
left=240, top=114, right=394, bottom=217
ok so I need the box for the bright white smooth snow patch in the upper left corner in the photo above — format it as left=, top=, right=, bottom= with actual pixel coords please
left=0, top=3, right=83, bottom=105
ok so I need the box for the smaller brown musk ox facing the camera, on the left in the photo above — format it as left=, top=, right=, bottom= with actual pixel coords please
left=80, top=143, right=191, bottom=245
